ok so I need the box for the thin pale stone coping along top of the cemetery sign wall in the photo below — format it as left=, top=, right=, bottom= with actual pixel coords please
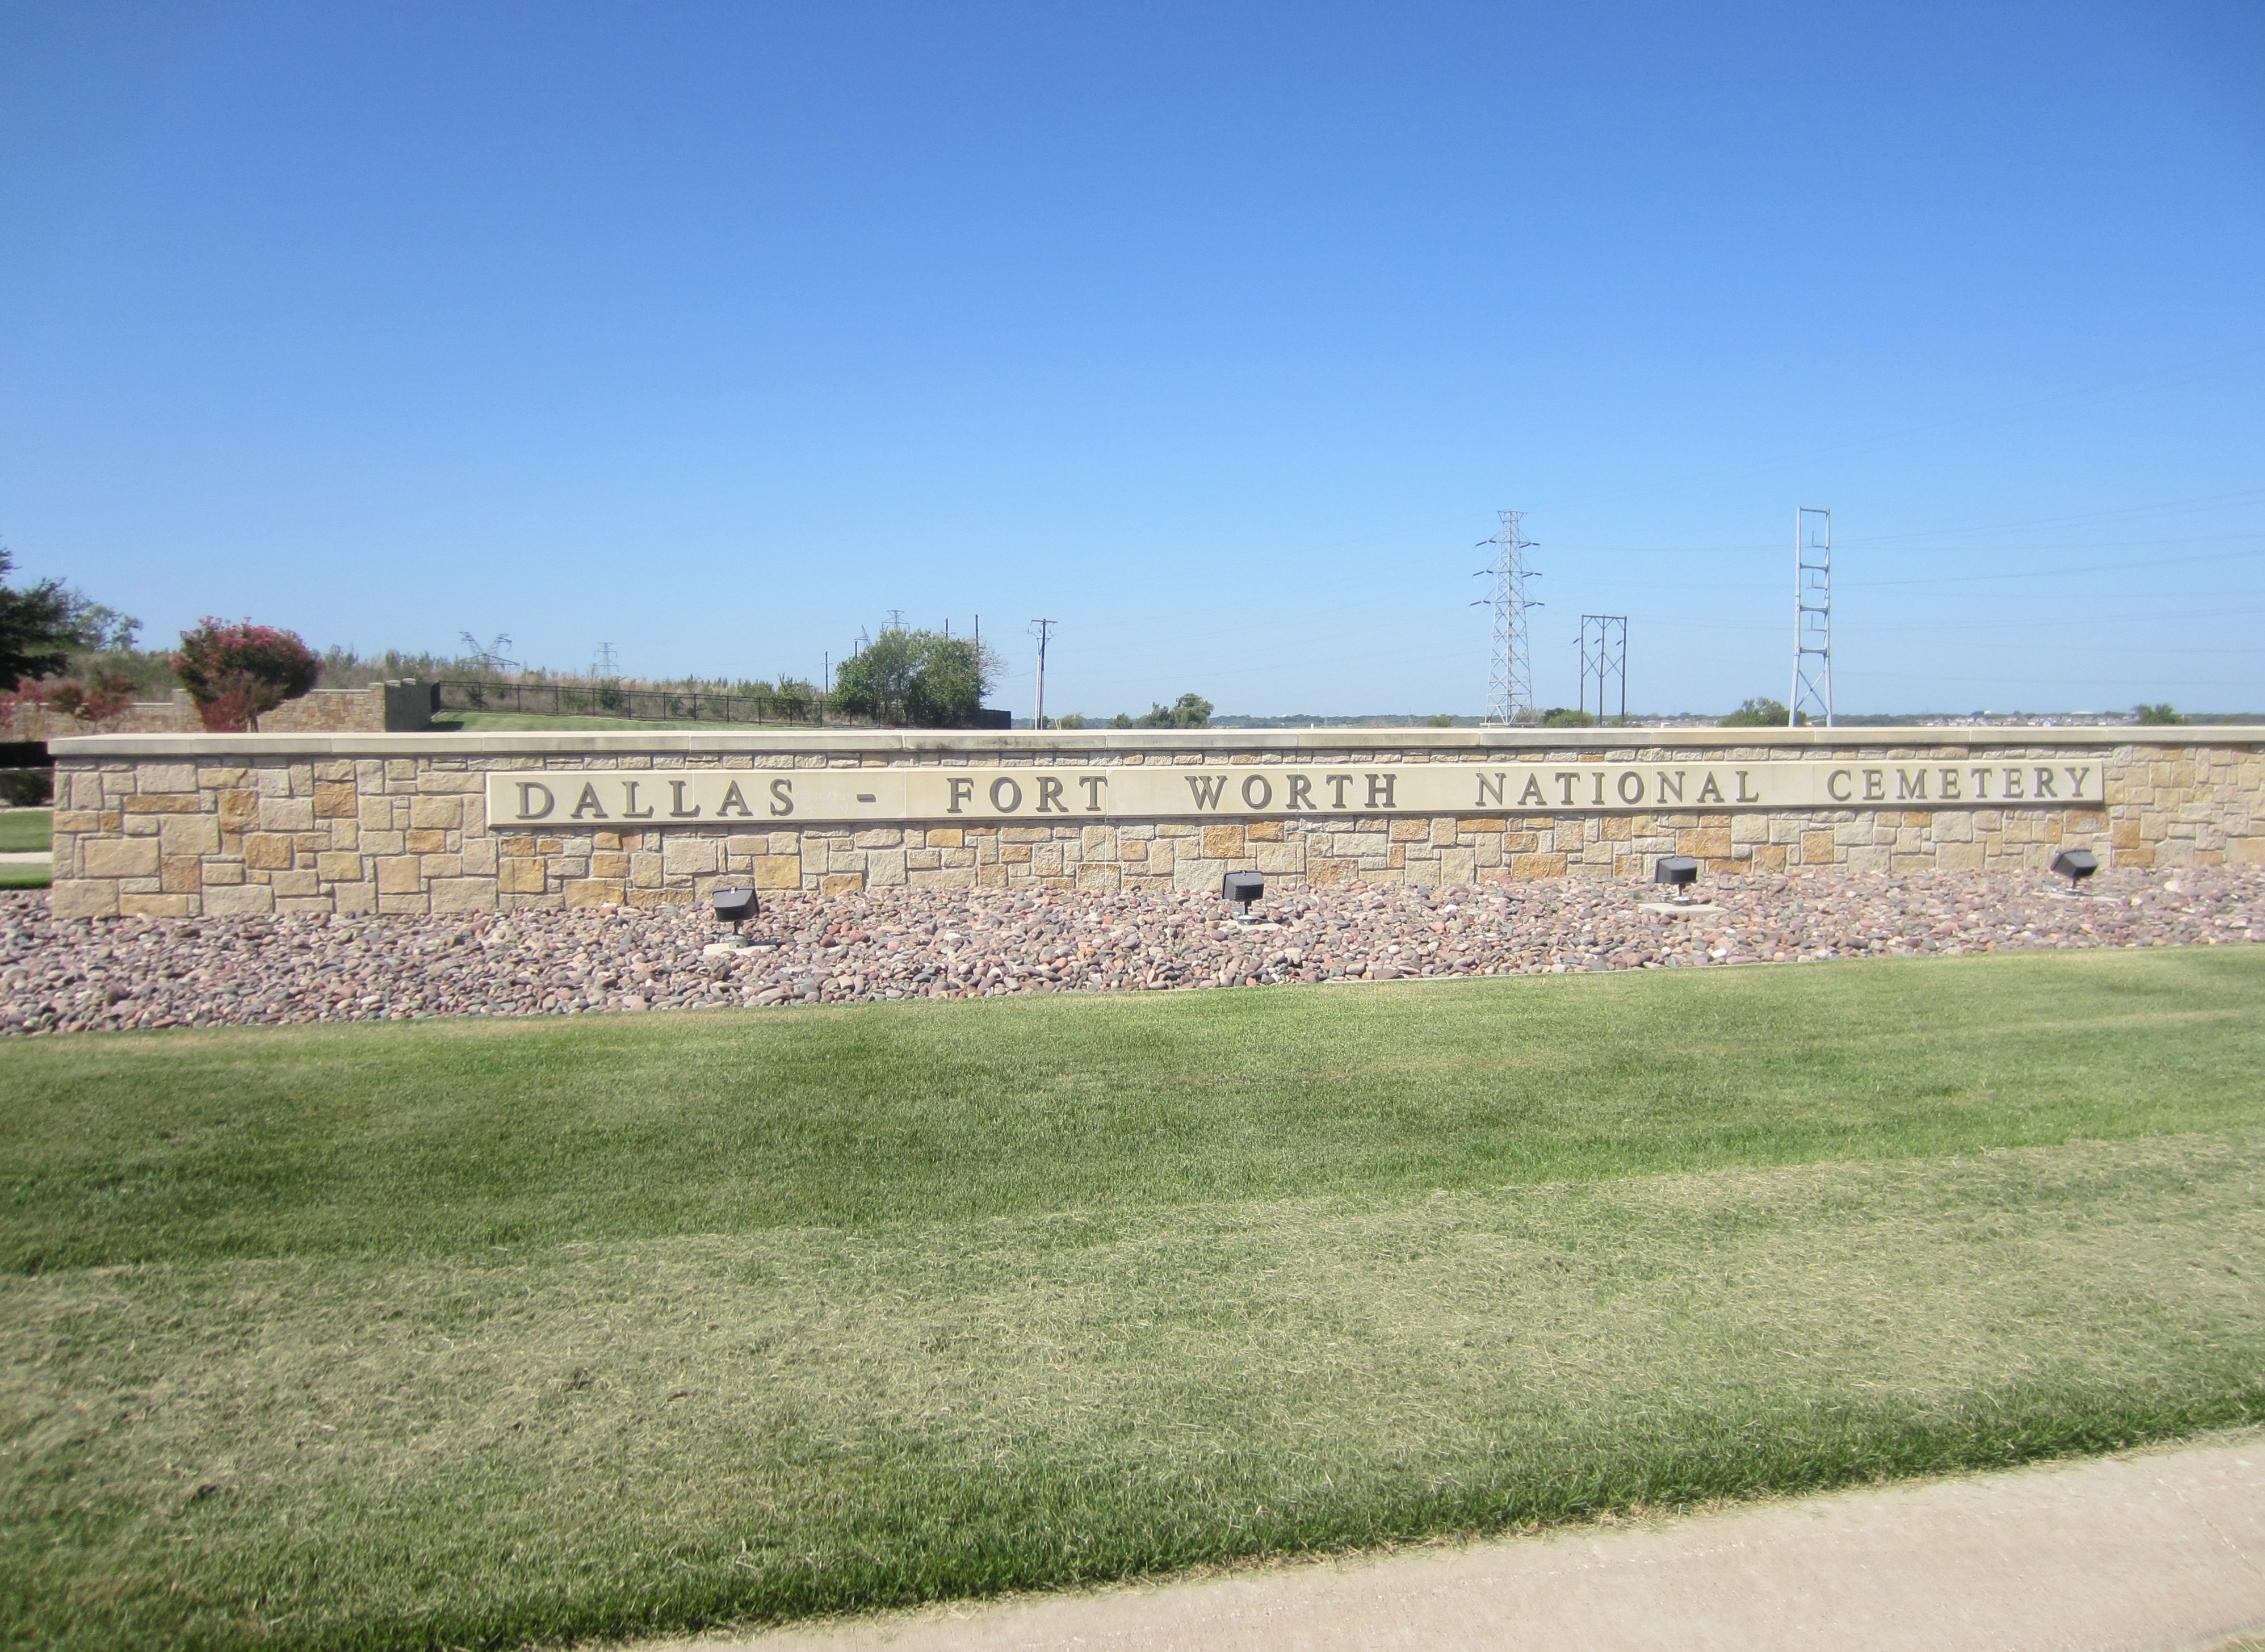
left=48, top=723, right=2265, bottom=759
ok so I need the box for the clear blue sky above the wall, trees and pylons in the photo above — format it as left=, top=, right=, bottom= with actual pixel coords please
left=0, top=0, right=2265, bottom=714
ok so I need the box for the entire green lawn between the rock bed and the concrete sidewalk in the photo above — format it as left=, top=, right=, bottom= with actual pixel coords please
left=0, top=947, right=2265, bottom=1647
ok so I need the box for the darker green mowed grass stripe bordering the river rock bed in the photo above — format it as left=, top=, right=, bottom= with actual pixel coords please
left=0, top=947, right=2265, bottom=1271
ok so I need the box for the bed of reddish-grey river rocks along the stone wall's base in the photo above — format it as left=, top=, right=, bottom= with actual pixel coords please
left=0, top=866, right=2265, bottom=1033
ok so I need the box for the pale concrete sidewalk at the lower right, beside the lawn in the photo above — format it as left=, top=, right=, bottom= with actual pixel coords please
left=677, top=1432, right=2265, bottom=1652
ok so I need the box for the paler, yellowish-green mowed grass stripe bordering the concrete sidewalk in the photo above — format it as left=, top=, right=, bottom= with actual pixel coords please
left=0, top=1129, right=2265, bottom=1647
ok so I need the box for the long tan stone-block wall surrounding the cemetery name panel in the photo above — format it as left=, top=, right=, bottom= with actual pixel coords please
left=52, top=729, right=2265, bottom=918
